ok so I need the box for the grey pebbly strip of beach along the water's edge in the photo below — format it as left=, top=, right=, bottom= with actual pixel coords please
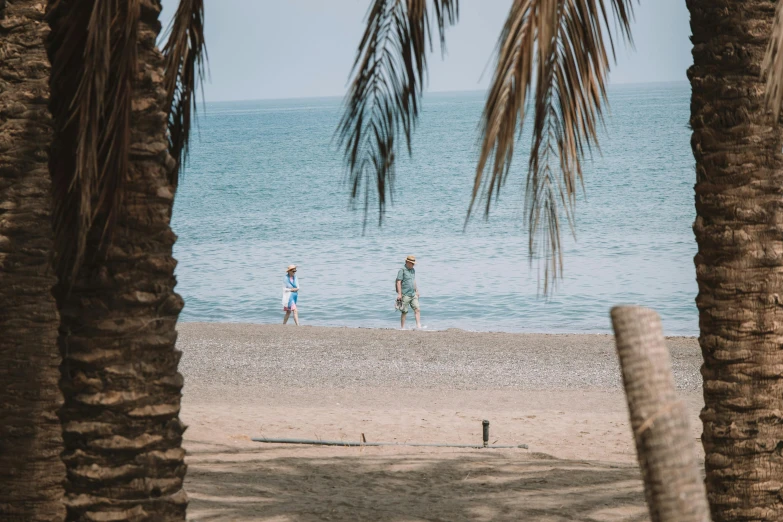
left=177, top=323, right=702, bottom=391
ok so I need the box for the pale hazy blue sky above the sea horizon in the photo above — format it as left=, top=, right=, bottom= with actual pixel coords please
left=161, top=0, right=692, bottom=101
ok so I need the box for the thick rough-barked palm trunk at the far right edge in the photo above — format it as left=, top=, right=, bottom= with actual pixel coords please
left=687, top=0, right=783, bottom=521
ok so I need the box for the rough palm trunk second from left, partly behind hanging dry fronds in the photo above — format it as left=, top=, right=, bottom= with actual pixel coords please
left=49, top=0, right=187, bottom=521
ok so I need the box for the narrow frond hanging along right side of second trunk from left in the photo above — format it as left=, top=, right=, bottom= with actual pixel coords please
left=163, top=0, right=207, bottom=187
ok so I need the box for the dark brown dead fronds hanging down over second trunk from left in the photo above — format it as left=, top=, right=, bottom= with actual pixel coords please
left=47, top=0, right=141, bottom=282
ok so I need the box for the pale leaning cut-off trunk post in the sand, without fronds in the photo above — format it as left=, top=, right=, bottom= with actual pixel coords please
left=611, top=306, right=710, bottom=522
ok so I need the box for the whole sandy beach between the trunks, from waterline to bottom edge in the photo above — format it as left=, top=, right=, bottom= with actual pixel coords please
left=178, top=323, right=702, bottom=521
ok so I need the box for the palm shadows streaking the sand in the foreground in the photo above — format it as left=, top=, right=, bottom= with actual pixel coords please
left=187, top=446, right=648, bottom=522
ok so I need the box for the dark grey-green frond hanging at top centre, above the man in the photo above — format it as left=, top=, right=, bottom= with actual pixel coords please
left=337, top=0, right=459, bottom=222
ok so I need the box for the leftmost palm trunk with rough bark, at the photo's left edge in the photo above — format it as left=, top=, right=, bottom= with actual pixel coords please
left=0, top=0, right=65, bottom=522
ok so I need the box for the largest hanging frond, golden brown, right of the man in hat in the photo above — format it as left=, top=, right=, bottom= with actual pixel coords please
left=468, top=0, right=633, bottom=294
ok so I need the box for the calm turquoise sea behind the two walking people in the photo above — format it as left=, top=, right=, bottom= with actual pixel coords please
left=172, top=83, right=698, bottom=335
